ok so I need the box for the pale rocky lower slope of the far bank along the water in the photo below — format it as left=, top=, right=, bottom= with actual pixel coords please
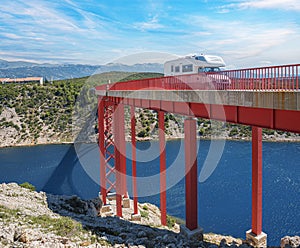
left=0, top=107, right=300, bottom=148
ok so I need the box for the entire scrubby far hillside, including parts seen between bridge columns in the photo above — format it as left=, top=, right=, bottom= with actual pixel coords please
left=0, top=72, right=299, bottom=146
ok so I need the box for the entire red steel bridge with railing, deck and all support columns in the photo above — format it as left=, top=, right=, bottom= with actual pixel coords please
left=96, top=64, right=300, bottom=247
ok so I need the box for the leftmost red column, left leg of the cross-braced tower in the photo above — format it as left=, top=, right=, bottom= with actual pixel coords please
left=98, top=97, right=106, bottom=205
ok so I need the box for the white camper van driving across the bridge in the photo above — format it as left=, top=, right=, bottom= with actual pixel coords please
left=164, top=55, right=225, bottom=76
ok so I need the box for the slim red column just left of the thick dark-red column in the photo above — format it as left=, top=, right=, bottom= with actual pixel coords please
left=158, top=111, right=167, bottom=226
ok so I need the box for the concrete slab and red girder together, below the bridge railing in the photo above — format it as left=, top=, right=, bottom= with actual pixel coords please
left=96, top=90, right=300, bottom=133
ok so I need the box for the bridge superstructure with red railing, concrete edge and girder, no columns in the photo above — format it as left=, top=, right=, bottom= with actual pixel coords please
left=96, top=64, right=300, bottom=133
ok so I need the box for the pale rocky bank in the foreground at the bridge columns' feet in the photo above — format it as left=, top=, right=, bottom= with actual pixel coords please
left=0, top=183, right=286, bottom=248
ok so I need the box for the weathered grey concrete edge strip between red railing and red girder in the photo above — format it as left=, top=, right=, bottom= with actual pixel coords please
left=96, top=90, right=300, bottom=110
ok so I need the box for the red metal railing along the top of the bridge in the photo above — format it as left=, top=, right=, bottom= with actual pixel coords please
left=96, top=64, right=300, bottom=91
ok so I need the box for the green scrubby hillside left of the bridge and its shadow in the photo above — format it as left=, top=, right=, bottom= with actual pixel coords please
left=0, top=72, right=162, bottom=146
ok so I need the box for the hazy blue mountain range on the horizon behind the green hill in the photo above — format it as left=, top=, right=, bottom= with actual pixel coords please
left=0, top=60, right=163, bottom=80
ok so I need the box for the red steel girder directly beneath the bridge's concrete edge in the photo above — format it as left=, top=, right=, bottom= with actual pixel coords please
left=109, top=98, right=300, bottom=133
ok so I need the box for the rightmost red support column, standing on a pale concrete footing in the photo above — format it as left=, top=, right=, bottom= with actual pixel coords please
left=252, top=127, right=262, bottom=235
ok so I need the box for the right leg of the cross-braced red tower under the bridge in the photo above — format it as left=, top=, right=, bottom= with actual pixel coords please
left=113, top=104, right=126, bottom=217
